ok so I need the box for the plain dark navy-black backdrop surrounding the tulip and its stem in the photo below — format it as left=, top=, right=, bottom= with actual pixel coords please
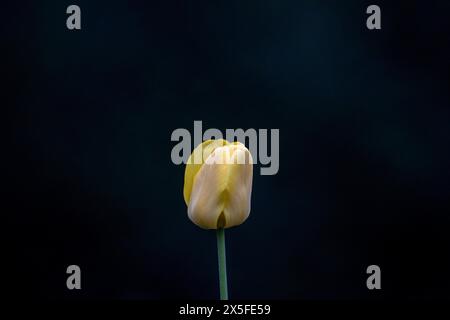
left=1, top=0, right=450, bottom=299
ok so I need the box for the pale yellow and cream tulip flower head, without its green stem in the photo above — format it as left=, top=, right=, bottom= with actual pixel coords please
left=183, top=139, right=253, bottom=229
